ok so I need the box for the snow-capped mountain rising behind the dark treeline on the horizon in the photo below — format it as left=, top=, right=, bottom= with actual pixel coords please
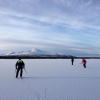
left=3, top=49, right=63, bottom=56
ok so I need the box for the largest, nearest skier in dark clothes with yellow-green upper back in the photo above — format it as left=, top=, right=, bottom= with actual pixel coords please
left=15, top=58, right=25, bottom=78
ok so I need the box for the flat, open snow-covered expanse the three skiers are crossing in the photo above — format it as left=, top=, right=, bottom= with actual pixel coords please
left=0, top=59, right=100, bottom=100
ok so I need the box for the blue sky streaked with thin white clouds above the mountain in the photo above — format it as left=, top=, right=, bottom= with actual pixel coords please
left=0, top=0, right=100, bottom=56
